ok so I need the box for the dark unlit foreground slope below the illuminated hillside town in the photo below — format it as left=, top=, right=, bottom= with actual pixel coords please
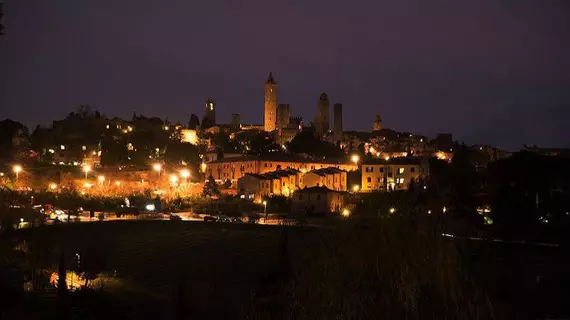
left=6, top=221, right=570, bottom=319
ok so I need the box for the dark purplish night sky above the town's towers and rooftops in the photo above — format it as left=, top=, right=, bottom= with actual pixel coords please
left=0, top=0, right=570, bottom=149
